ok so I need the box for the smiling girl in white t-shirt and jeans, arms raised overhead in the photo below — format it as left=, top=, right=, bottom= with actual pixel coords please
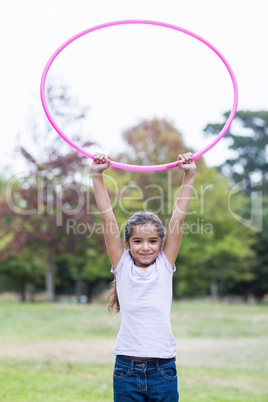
left=91, top=153, right=196, bottom=402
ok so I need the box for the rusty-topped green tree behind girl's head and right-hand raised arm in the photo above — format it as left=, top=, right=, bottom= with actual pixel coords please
left=111, top=119, right=252, bottom=297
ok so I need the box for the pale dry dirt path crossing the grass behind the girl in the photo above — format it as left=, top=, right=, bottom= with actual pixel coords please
left=0, top=338, right=268, bottom=369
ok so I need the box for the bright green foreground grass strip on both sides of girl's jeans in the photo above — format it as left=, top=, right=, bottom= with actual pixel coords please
left=0, top=360, right=268, bottom=402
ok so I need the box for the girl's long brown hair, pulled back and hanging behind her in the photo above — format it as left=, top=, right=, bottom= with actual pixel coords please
left=107, top=211, right=165, bottom=313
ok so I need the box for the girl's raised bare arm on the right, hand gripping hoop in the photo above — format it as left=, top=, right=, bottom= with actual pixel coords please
left=164, top=152, right=196, bottom=266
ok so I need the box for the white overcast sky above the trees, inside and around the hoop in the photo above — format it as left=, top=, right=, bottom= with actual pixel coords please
left=0, top=0, right=268, bottom=172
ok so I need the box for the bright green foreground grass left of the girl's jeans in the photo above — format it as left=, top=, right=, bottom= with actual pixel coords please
left=0, top=359, right=113, bottom=402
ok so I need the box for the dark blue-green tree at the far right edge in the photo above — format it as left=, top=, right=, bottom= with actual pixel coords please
left=204, top=111, right=268, bottom=298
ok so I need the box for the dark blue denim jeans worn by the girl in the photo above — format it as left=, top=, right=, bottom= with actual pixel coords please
left=113, top=356, right=179, bottom=402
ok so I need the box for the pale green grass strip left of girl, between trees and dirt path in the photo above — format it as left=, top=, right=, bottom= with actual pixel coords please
left=0, top=302, right=120, bottom=339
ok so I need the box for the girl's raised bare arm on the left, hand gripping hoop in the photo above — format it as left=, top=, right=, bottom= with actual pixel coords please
left=91, top=154, right=123, bottom=268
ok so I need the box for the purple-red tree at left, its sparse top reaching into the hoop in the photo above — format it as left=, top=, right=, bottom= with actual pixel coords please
left=0, top=81, right=109, bottom=301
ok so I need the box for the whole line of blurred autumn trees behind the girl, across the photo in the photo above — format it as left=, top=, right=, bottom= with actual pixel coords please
left=0, top=86, right=268, bottom=301
